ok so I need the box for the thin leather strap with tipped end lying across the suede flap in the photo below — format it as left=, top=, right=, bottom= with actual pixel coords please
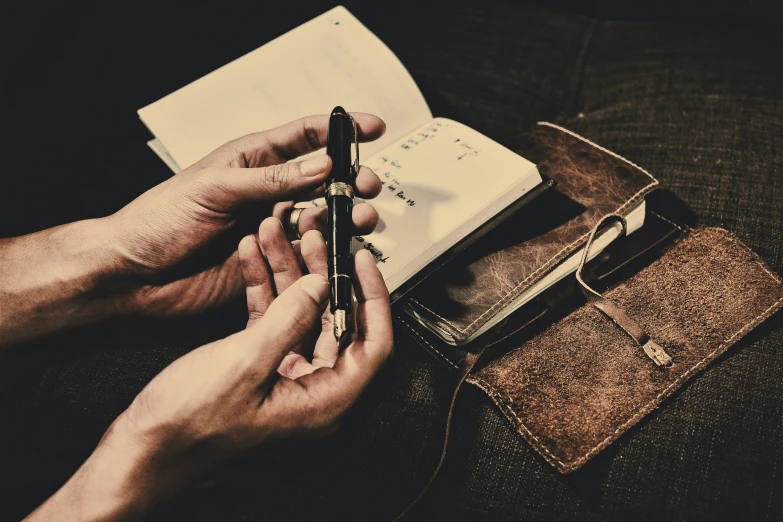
left=576, top=214, right=672, bottom=368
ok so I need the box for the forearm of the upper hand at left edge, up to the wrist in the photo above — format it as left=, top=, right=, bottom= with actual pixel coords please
left=0, top=219, right=121, bottom=347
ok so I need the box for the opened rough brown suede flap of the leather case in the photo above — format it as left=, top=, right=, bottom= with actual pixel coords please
left=468, top=228, right=783, bottom=473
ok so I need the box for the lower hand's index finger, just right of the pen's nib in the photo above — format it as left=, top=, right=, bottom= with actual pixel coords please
left=354, top=250, right=392, bottom=344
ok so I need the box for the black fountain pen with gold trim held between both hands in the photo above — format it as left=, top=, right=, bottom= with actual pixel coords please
left=326, top=107, right=359, bottom=343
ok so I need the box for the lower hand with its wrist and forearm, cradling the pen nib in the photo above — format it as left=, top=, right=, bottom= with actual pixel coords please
left=24, top=234, right=392, bottom=520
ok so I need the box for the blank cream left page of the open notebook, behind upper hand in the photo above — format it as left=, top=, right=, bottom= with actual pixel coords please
left=139, top=6, right=432, bottom=168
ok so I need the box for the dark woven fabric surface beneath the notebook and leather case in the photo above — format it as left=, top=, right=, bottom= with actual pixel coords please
left=0, top=2, right=783, bottom=520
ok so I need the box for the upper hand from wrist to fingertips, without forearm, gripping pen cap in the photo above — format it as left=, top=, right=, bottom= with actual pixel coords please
left=108, top=113, right=385, bottom=315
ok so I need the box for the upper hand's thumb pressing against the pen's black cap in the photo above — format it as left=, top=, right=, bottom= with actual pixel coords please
left=200, top=154, right=332, bottom=212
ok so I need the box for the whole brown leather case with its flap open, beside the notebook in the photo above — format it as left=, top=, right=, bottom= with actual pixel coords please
left=395, top=124, right=783, bottom=473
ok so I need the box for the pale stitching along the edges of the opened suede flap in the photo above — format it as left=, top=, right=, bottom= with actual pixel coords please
left=466, top=227, right=783, bottom=471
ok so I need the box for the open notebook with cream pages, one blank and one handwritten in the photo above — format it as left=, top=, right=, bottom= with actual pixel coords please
left=139, top=6, right=643, bottom=344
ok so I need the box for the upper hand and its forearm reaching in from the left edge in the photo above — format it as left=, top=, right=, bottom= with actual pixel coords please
left=0, top=113, right=385, bottom=349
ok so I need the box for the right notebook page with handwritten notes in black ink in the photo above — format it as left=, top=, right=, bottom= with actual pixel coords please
left=354, top=118, right=541, bottom=291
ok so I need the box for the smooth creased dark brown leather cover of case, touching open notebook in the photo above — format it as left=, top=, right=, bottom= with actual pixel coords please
left=406, top=123, right=658, bottom=342
